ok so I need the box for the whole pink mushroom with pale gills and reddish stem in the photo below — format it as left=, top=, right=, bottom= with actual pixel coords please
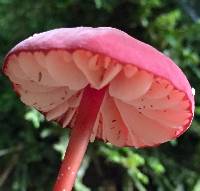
left=3, top=27, right=194, bottom=191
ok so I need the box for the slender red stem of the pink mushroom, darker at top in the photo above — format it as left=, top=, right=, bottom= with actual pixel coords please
left=53, top=86, right=106, bottom=191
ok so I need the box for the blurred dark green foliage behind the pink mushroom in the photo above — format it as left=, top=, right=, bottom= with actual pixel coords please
left=0, top=0, right=200, bottom=191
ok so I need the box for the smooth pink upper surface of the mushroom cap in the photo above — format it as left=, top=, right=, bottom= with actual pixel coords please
left=2, top=27, right=194, bottom=113
